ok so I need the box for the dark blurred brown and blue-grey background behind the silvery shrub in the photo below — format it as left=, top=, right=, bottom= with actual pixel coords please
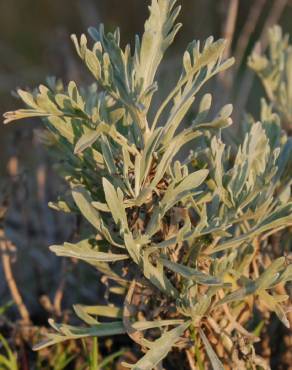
left=0, top=0, right=292, bottom=368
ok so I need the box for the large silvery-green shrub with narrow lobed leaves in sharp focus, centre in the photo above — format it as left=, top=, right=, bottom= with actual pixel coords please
left=5, top=0, right=292, bottom=369
